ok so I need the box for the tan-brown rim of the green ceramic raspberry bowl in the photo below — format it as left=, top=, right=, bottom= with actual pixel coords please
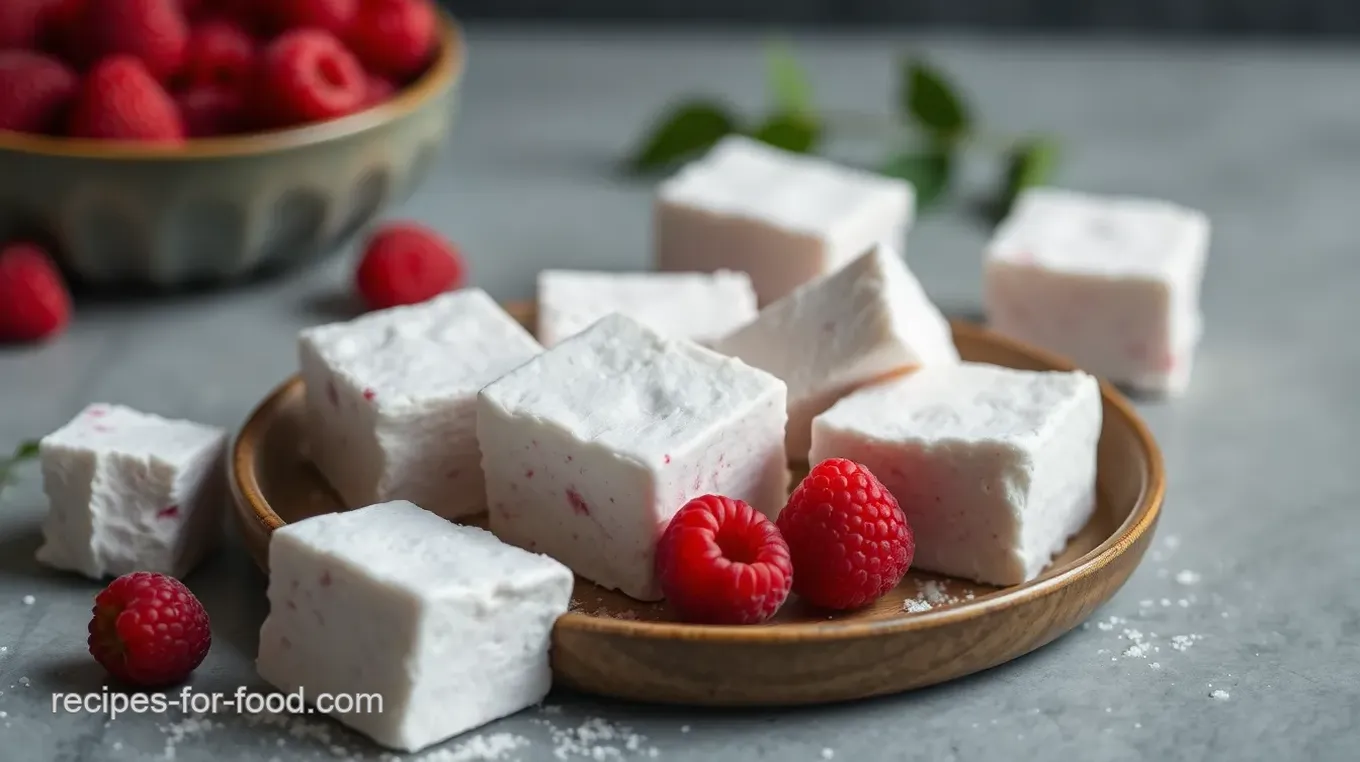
left=0, top=4, right=468, bottom=163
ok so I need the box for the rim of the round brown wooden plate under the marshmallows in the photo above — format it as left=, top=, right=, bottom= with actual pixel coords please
left=228, top=315, right=1166, bottom=645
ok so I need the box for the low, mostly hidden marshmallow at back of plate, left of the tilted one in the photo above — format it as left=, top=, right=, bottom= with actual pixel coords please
left=539, top=269, right=756, bottom=347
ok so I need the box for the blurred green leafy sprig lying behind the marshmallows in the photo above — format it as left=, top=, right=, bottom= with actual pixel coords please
left=628, top=42, right=1061, bottom=218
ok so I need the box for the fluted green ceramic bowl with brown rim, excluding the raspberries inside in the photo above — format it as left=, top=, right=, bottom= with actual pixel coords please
left=0, top=16, right=464, bottom=287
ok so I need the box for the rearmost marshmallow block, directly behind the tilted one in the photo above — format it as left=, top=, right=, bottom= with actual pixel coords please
left=653, top=136, right=915, bottom=305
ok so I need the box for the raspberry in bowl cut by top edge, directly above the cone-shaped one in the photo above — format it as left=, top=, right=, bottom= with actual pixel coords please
left=83, top=0, right=189, bottom=82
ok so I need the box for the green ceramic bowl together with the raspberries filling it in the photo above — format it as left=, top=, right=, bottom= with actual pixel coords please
left=0, top=0, right=464, bottom=287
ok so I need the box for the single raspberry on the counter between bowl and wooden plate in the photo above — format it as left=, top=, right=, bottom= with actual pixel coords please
left=355, top=222, right=464, bottom=309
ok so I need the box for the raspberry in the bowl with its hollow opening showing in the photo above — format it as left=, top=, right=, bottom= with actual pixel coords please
left=261, top=29, right=367, bottom=125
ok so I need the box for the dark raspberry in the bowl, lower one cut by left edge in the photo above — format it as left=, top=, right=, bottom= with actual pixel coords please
left=0, top=50, right=79, bottom=133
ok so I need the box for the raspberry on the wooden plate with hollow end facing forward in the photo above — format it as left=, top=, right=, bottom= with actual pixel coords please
left=657, top=495, right=793, bottom=625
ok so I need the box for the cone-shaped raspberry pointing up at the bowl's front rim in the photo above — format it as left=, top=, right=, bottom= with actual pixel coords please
left=68, top=56, right=184, bottom=144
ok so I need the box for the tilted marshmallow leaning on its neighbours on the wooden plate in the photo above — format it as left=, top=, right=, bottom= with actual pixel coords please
left=713, top=246, right=959, bottom=459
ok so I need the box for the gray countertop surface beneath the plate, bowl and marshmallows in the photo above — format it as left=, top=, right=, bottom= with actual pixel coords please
left=0, top=29, right=1360, bottom=762
